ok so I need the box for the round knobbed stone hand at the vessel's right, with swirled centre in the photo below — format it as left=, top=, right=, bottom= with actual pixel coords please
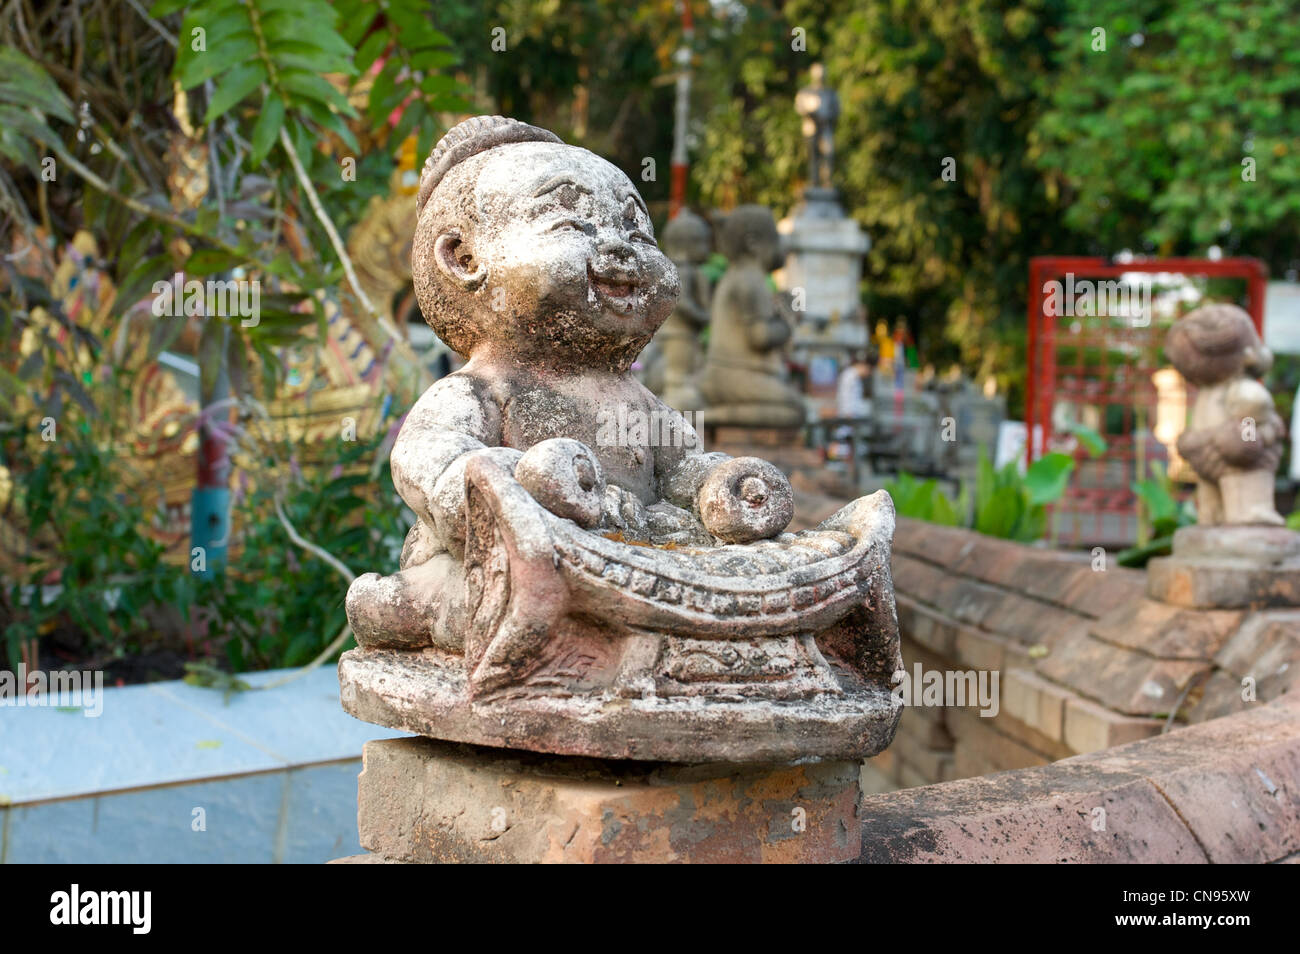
left=699, top=458, right=794, bottom=543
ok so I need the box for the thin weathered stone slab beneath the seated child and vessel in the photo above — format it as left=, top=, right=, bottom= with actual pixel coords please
left=338, top=647, right=902, bottom=763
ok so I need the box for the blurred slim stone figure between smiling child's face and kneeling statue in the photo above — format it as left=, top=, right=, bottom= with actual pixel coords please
left=654, top=209, right=712, bottom=411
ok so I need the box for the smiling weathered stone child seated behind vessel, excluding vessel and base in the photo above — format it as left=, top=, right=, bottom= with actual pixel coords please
left=347, top=116, right=793, bottom=651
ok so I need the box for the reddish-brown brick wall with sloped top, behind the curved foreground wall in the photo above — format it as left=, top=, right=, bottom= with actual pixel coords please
left=863, top=519, right=1300, bottom=792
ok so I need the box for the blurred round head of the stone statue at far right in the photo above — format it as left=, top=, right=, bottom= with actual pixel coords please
left=1165, top=304, right=1273, bottom=386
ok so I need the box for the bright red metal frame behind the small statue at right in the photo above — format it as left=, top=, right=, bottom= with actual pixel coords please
left=1024, top=256, right=1269, bottom=545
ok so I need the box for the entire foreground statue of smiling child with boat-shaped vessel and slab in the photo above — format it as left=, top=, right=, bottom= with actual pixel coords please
left=339, top=117, right=901, bottom=762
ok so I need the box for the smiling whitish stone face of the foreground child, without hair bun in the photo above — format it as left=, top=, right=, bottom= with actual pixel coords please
left=421, top=143, right=679, bottom=370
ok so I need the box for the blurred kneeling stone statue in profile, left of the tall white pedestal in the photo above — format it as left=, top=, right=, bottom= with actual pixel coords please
left=698, top=205, right=806, bottom=428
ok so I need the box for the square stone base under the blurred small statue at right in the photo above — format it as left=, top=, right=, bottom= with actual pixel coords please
left=1147, top=525, right=1300, bottom=610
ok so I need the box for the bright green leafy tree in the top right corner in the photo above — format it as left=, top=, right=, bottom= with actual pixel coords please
left=1034, top=0, right=1300, bottom=273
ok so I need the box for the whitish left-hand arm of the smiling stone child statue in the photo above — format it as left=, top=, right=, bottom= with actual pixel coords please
left=390, top=374, right=521, bottom=551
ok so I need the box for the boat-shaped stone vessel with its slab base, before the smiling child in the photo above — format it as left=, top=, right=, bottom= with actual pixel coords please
left=339, top=456, right=901, bottom=762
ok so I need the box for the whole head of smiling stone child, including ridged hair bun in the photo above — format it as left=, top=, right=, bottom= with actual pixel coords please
left=411, top=116, right=679, bottom=370
